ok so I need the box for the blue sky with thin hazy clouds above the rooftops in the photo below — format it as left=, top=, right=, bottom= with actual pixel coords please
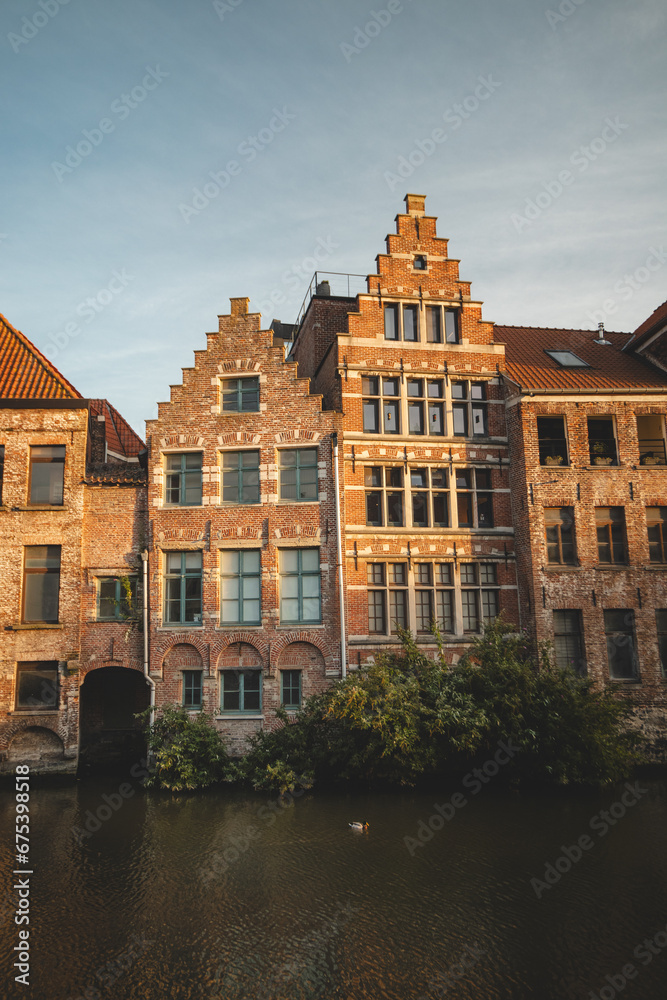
left=0, top=0, right=667, bottom=436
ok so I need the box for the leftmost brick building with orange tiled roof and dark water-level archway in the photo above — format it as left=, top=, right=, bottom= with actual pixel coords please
left=0, top=317, right=146, bottom=771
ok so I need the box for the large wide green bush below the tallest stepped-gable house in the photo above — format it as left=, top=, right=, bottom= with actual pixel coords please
left=241, top=619, right=635, bottom=791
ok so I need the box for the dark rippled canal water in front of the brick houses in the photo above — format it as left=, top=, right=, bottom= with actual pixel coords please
left=0, top=769, right=667, bottom=1000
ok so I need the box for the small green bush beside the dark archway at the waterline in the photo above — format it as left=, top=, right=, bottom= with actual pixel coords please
left=142, top=705, right=233, bottom=792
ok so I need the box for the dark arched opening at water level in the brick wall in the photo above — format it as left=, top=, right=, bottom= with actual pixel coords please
left=79, top=667, right=149, bottom=770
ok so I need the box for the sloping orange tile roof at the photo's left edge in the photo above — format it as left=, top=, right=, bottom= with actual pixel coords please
left=0, top=314, right=83, bottom=399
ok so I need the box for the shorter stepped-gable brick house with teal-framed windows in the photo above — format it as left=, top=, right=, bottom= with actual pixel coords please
left=147, top=298, right=341, bottom=749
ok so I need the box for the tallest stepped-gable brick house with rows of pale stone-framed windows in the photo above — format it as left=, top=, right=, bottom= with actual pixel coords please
left=291, top=195, right=518, bottom=666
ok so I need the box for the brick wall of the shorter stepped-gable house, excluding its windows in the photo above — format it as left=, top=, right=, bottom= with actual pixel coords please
left=147, top=299, right=340, bottom=752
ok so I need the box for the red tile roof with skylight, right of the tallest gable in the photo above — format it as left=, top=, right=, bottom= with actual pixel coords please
left=494, top=326, right=667, bottom=391
